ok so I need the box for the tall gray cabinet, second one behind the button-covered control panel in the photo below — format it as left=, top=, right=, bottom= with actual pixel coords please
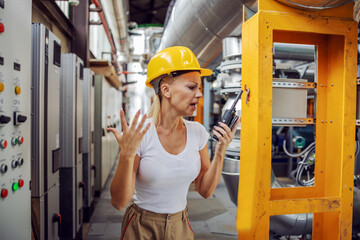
left=60, top=53, right=85, bottom=239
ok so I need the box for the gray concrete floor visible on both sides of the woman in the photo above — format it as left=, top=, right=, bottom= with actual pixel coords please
left=83, top=166, right=237, bottom=240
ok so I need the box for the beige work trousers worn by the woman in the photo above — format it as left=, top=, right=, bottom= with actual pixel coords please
left=121, top=203, right=194, bottom=240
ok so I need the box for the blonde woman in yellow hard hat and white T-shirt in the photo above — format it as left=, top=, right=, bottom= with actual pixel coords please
left=109, top=47, right=239, bottom=240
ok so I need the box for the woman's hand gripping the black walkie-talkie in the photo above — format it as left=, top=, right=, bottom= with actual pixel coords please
left=213, top=118, right=240, bottom=157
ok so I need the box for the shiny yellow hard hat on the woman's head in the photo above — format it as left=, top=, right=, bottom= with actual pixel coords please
left=145, top=46, right=212, bottom=88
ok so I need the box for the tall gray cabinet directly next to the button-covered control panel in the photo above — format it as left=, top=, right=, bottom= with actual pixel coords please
left=31, top=23, right=61, bottom=239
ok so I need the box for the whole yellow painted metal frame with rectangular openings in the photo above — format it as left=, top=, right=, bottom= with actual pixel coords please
left=236, top=0, right=357, bottom=240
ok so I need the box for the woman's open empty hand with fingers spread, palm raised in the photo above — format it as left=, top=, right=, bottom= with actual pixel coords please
left=108, top=109, right=151, bottom=157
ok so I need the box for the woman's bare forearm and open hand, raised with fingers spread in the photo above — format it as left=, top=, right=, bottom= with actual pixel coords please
left=108, top=110, right=150, bottom=209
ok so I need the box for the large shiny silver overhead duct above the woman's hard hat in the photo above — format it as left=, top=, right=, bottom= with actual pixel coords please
left=158, top=0, right=257, bottom=67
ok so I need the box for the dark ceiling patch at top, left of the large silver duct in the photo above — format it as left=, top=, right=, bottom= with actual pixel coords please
left=129, top=0, right=171, bottom=25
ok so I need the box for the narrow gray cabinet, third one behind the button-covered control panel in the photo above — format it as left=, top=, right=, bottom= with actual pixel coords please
left=83, top=68, right=96, bottom=222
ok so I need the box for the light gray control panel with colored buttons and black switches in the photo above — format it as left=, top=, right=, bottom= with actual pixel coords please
left=0, top=0, right=32, bottom=240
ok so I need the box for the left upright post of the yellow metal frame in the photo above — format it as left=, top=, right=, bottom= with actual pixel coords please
left=237, top=8, right=272, bottom=239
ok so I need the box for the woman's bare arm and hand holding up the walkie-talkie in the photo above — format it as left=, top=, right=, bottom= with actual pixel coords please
left=195, top=120, right=240, bottom=198
